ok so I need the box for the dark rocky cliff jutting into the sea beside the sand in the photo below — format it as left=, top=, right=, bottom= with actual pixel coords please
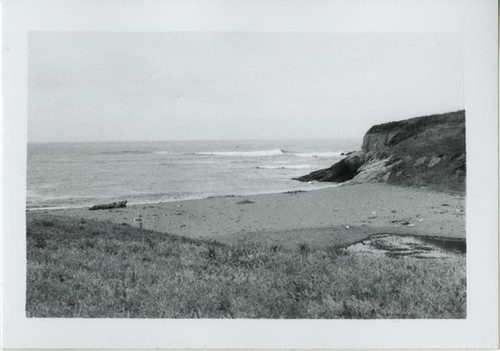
left=295, top=111, right=466, bottom=192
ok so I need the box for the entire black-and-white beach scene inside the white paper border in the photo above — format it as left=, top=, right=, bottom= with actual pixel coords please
left=26, top=32, right=467, bottom=319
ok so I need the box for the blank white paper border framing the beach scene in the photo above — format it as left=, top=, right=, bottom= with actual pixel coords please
left=1, top=0, right=498, bottom=349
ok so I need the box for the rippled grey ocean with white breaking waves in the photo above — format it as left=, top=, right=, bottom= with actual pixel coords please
left=26, top=139, right=361, bottom=208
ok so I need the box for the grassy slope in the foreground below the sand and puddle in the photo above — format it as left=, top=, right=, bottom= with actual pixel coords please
left=26, top=212, right=466, bottom=318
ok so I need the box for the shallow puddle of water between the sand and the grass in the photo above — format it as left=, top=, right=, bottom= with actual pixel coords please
left=346, top=234, right=466, bottom=258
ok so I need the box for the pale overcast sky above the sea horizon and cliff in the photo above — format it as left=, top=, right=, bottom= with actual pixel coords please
left=28, top=32, right=464, bottom=142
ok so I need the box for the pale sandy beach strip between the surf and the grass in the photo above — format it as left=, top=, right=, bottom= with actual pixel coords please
left=38, top=184, right=465, bottom=247
